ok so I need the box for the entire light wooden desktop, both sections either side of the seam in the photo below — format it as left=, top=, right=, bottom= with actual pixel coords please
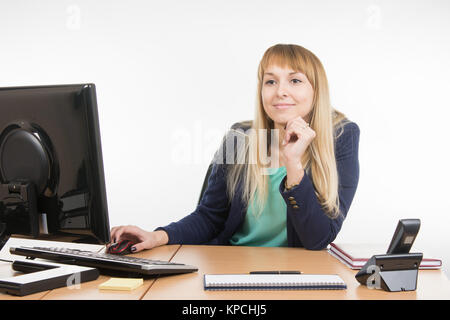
left=0, top=245, right=450, bottom=300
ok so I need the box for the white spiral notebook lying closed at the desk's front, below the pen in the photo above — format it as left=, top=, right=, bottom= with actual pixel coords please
left=204, top=274, right=347, bottom=290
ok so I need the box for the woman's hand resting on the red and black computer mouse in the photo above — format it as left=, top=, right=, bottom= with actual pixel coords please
left=111, top=226, right=169, bottom=253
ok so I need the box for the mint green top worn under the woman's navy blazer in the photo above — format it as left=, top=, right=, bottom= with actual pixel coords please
left=230, top=167, right=288, bottom=247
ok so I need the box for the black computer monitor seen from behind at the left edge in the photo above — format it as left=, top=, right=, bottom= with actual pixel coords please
left=0, top=84, right=110, bottom=244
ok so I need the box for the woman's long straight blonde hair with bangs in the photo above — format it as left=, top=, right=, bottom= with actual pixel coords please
left=227, top=44, right=346, bottom=218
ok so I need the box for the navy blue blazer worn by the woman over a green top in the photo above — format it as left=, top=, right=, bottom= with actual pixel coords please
left=156, top=122, right=360, bottom=250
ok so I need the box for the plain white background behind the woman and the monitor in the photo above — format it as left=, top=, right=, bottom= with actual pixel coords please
left=0, top=0, right=450, bottom=278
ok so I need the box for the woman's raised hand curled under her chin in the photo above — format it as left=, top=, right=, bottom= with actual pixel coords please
left=282, top=116, right=316, bottom=166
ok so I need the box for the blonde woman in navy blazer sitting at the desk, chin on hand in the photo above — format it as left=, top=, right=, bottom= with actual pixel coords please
left=111, top=44, right=359, bottom=252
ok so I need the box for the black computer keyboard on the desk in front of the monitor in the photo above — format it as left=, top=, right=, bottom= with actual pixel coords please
left=9, top=247, right=198, bottom=275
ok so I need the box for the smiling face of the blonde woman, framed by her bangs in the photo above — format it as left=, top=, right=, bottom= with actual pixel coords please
left=261, top=65, right=314, bottom=128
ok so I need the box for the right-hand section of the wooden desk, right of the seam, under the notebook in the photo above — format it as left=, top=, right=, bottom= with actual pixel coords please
left=143, top=245, right=450, bottom=300
